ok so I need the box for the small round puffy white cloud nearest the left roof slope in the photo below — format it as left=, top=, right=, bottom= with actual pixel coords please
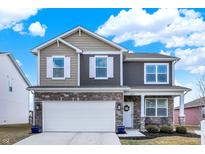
left=28, top=21, right=47, bottom=37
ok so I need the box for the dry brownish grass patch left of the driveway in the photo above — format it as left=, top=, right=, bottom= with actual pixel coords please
left=0, top=124, right=31, bottom=145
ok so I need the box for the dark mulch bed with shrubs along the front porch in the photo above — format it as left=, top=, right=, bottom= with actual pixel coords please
left=119, top=132, right=200, bottom=140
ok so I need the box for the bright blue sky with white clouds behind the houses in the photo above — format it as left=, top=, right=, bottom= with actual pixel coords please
left=0, top=8, right=205, bottom=102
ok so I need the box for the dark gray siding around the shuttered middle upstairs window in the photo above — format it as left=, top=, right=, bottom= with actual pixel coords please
left=80, top=55, right=120, bottom=86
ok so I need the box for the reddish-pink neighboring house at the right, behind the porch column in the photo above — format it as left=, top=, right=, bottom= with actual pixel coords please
left=175, top=97, right=205, bottom=125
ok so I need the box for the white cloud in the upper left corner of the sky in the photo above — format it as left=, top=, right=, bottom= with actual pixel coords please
left=0, top=8, right=38, bottom=30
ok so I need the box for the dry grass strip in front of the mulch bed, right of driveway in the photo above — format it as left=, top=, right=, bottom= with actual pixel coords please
left=121, top=136, right=200, bottom=145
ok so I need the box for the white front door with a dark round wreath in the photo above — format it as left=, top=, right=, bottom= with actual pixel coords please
left=123, top=102, right=133, bottom=128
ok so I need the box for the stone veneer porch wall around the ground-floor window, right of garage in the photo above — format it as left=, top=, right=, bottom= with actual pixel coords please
left=124, top=96, right=174, bottom=129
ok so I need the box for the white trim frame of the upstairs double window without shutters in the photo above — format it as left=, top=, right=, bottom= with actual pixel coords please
left=144, top=63, right=169, bottom=84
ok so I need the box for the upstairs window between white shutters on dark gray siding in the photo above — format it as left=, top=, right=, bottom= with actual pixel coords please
left=95, top=57, right=107, bottom=78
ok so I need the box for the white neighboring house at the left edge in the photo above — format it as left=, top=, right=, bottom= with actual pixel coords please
left=0, top=52, right=31, bottom=125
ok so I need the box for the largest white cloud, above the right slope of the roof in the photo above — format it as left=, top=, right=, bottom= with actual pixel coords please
left=96, top=9, right=205, bottom=48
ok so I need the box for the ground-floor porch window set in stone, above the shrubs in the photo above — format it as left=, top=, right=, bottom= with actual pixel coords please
left=145, top=98, right=168, bottom=117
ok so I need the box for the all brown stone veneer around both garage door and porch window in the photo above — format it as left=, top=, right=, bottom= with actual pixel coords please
left=34, top=92, right=174, bottom=132
